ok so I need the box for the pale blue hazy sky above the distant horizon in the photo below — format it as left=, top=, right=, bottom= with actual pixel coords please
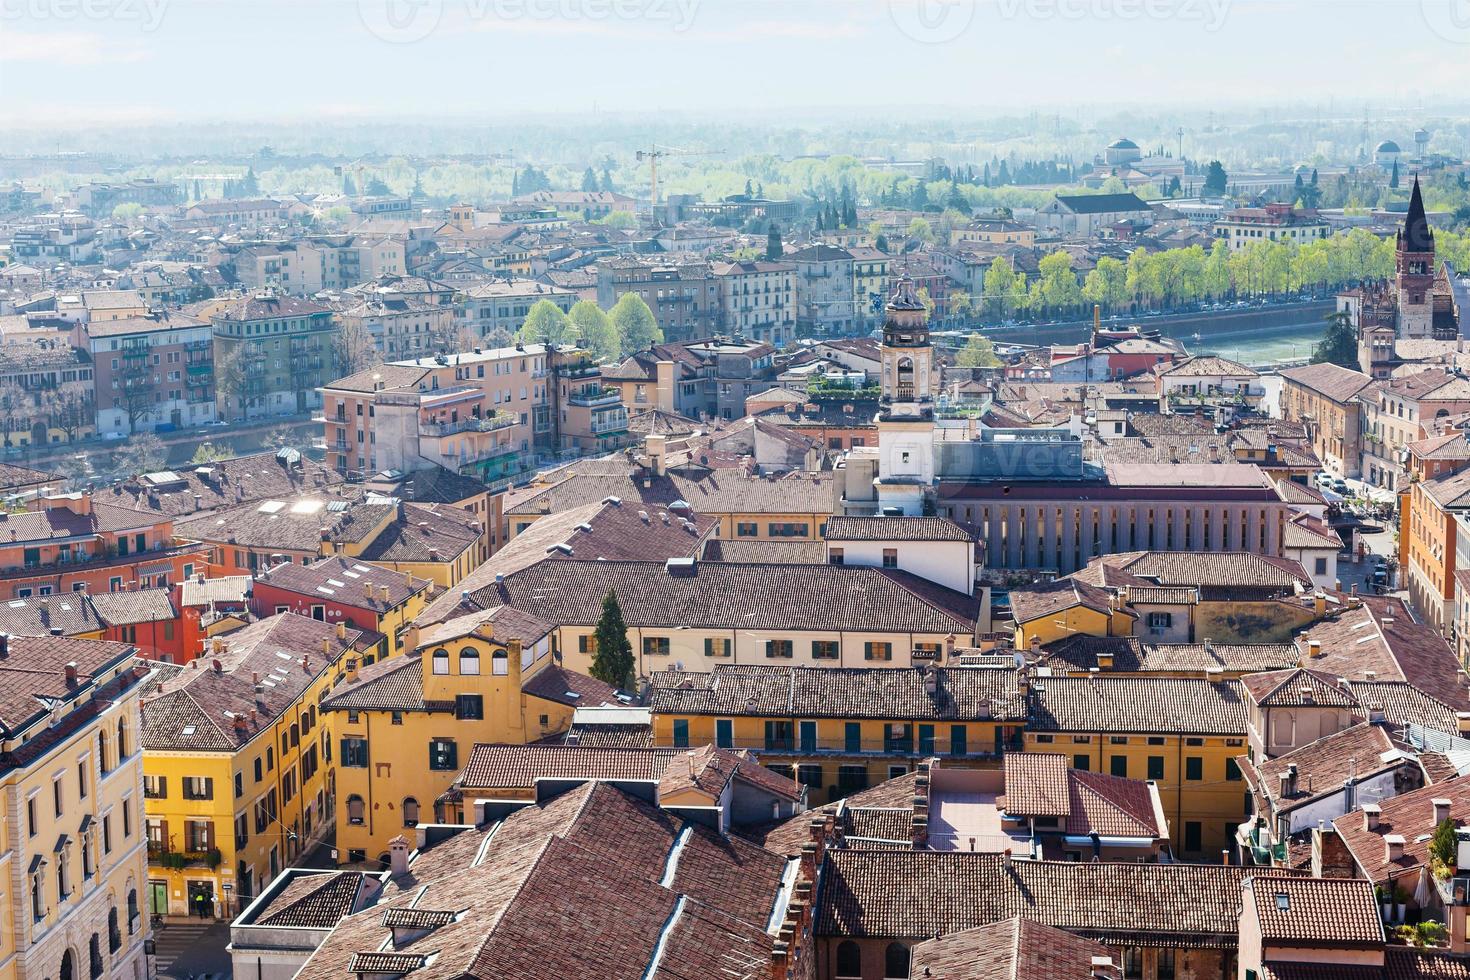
left=0, top=0, right=1470, bottom=125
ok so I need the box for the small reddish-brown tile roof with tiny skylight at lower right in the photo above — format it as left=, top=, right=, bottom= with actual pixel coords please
left=1245, top=876, right=1383, bottom=948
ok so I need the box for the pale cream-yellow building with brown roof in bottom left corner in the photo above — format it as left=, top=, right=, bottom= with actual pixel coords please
left=0, top=636, right=150, bottom=980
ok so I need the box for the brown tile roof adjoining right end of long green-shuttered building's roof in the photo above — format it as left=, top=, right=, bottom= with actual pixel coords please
left=1030, top=674, right=1245, bottom=736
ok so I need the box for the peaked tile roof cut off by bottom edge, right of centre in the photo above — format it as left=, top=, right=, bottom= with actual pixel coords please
left=908, top=917, right=1122, bottom=980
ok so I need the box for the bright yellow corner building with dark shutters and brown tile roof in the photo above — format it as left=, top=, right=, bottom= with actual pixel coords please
left=143, top=613, right=362, bottom=918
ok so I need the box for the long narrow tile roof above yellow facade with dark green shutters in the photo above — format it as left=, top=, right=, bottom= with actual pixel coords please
left=650, top=664, right=1025, bottom=721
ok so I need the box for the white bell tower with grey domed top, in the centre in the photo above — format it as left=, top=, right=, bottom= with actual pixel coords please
left=878, top=278, right=935, bottom=514
